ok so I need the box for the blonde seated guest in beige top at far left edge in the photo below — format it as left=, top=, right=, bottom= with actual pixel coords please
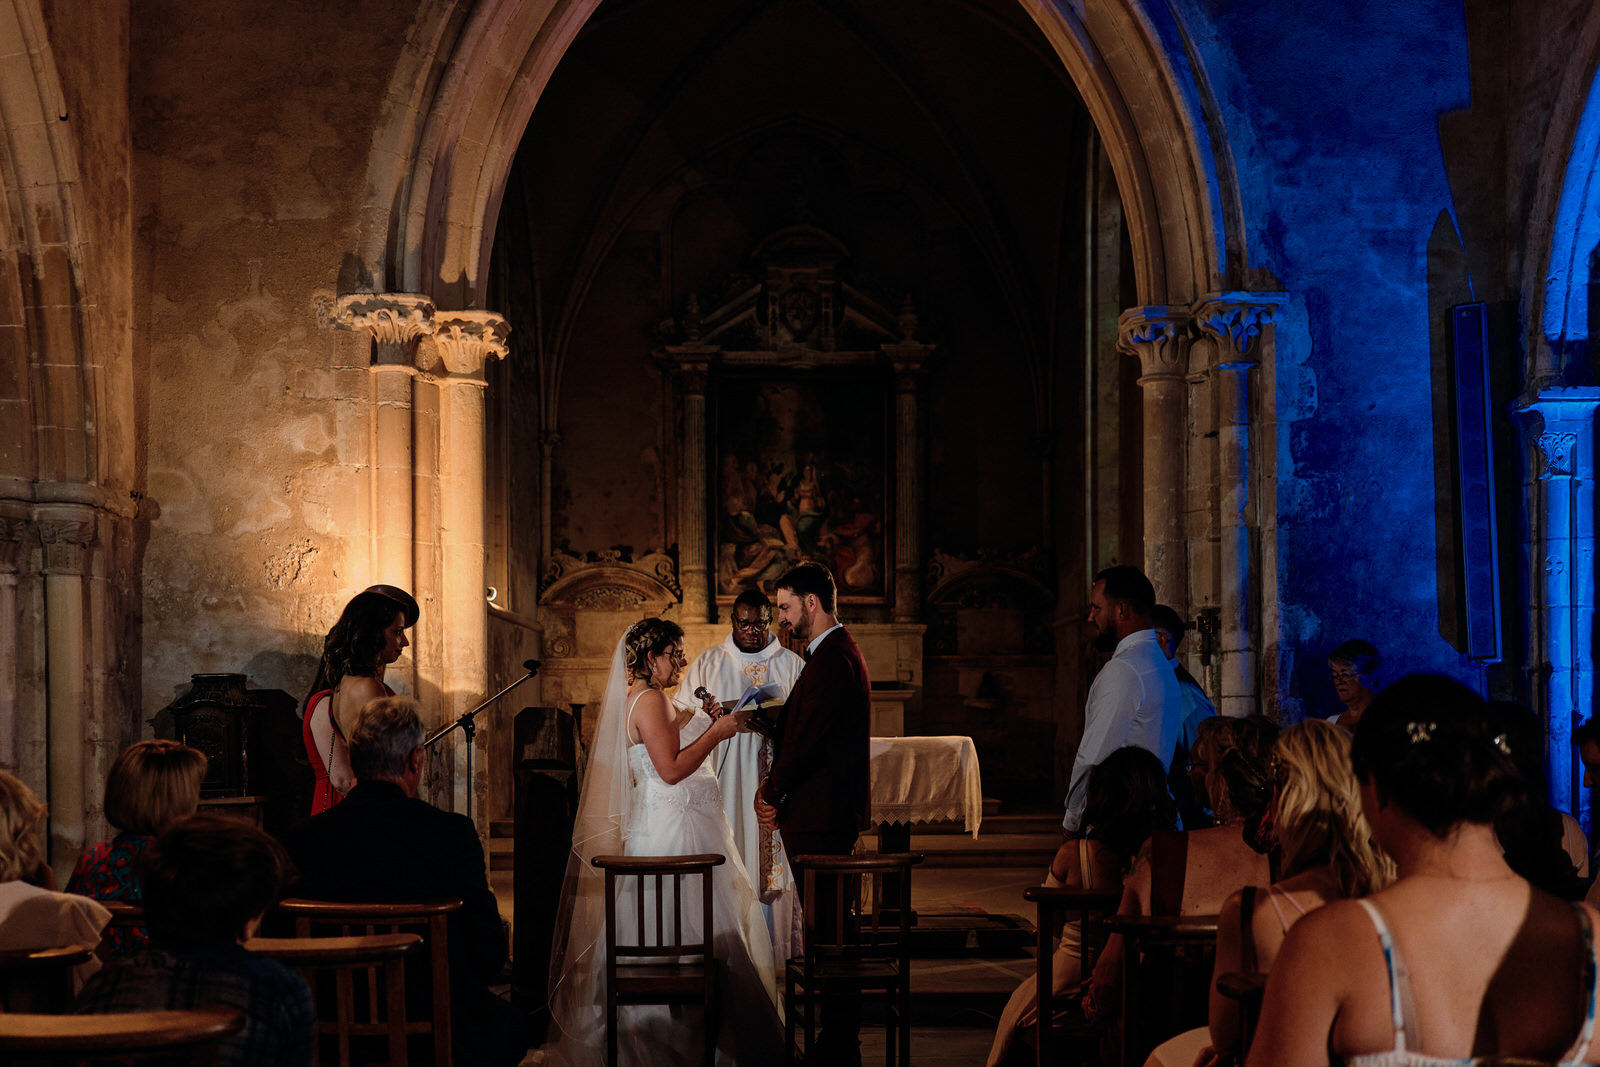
left=0, top=771, right=110, bottom=982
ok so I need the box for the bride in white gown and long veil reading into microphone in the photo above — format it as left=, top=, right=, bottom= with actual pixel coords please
left=544, top=619, right=784, bottom=1067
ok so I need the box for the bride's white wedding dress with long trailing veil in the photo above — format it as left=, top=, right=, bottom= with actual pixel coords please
left=546, top=633, right=784, bottom=1067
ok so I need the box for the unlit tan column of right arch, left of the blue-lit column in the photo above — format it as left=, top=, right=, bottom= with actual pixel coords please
left=1117, top=307, right=1194, bottom=617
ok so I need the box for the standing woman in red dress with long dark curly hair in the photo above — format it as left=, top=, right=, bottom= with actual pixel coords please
left=301, top=585, right=419, bottom=814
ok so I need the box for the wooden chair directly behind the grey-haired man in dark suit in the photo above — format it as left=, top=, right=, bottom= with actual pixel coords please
left=278, top=897, right=461, bottom=1067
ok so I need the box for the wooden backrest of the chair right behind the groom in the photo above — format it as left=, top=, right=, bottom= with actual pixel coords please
left=789, top=853, right=923, bottom=960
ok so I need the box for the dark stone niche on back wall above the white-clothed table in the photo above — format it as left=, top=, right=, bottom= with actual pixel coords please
left=920, top=549, right=1056, bottom=805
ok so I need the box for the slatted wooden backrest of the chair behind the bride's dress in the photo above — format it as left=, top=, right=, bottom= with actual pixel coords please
left=589, top=853, right=726, bottom=968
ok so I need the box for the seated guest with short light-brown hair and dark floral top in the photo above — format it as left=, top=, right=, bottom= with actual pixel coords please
left=67, top=741, right=206, bottom=958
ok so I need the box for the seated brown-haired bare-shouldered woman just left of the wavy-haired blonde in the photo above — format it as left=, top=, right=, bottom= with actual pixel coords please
left=1085, top=715, right=1278, bottom=1016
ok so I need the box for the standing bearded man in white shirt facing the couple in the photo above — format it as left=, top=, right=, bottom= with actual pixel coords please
left=1061, top=566, right=1182, bottom=830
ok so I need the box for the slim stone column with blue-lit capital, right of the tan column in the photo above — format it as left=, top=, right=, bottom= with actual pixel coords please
left=1195, top=293, right=1275, bottom=717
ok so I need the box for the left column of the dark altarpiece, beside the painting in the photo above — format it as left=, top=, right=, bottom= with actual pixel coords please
left=666, top=344, right=722, bottom=622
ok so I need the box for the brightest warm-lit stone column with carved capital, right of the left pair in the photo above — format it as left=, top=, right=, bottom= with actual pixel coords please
left=434, top=310, right=510, bottom=833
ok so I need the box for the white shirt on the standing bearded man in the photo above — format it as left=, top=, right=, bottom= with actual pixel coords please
left=1061, top=630, right=1182, bottom=830
